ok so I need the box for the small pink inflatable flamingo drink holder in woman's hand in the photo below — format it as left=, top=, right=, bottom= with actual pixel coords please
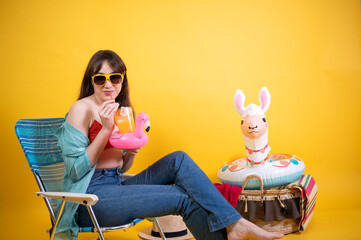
left=109, top=113, right=150, bottom=149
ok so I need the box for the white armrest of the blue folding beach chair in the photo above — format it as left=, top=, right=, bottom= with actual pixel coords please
left=36, top=192, right=99, bottom=206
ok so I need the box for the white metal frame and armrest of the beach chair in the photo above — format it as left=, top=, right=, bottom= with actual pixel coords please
left=15, top=119, right=166, bottom=240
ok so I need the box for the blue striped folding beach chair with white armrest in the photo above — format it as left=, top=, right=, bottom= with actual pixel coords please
left=15, top=118, right=166, bottom=240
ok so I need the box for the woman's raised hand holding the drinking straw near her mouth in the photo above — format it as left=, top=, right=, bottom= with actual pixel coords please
left=98, top=100, right=119, bottom=132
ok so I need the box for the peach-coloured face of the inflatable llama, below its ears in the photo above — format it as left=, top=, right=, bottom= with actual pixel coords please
left=241, top=114, right=268, bottom=139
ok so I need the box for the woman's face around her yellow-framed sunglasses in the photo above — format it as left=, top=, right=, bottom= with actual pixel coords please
left=93, top=61, right=122, bottom=102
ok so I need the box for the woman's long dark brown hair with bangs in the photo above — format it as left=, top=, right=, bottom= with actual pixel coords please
left=78, top=50, right=132, bottom=107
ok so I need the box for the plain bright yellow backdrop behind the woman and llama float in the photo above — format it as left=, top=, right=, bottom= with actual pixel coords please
left=0, top=0, right=361, bottom=239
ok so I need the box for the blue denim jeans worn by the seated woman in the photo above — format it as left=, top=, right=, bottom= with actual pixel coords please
left=78, top=151, right=241, bottom=240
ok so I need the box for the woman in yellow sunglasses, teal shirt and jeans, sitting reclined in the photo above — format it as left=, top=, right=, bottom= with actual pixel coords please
left=56, top=50, right=283, bottom=240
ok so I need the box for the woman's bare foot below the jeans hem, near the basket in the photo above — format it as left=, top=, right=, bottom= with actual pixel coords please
left=227, top=218, right=284, bottom=240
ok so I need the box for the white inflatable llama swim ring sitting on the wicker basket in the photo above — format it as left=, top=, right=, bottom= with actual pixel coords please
left=218, top=87, right=305, bottom=189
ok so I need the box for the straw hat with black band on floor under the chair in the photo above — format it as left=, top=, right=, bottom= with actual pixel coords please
left=139, top=215, right=193, bottom=240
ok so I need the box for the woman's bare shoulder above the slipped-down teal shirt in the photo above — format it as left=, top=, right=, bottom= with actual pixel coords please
left=67, top=99, right=92, bottom=135
